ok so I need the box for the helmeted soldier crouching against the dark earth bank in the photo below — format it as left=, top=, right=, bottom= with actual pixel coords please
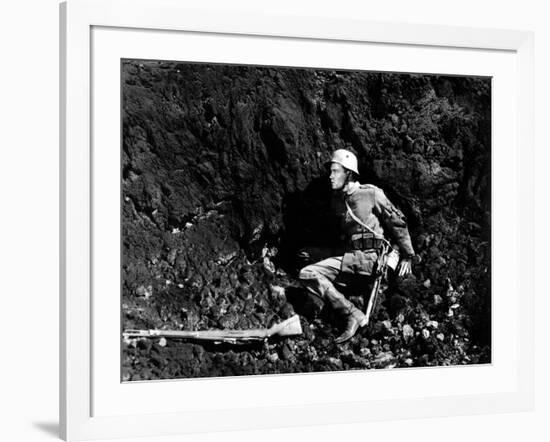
left=299, top=149, right=414, bottom=344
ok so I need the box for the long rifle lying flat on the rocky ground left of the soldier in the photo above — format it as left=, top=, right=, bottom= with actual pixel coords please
left=122, top=315, right=302, bottom=344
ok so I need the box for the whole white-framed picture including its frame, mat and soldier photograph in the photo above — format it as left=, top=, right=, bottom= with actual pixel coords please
left=60, top=0, right=534, bottom=440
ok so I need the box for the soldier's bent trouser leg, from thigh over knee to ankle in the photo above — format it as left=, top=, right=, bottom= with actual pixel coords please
left=299, top=256, right=365, bottom=322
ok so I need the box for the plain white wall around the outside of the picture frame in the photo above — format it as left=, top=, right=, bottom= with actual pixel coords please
left=0, top=0, right=550, bottom=442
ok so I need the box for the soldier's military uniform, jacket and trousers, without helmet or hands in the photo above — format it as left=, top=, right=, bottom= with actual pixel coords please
left=299, top=182, right=414, bottom=340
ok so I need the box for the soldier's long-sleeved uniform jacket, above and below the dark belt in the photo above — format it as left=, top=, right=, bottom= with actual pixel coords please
left=342, top=183, right=414, bottom=275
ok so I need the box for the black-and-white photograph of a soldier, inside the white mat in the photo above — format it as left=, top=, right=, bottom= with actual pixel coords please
left=120, top=59, right=492, bottom=382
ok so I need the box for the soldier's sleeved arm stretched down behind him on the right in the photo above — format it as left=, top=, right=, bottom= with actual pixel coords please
left=374, top=188, right=414, bottom=258
